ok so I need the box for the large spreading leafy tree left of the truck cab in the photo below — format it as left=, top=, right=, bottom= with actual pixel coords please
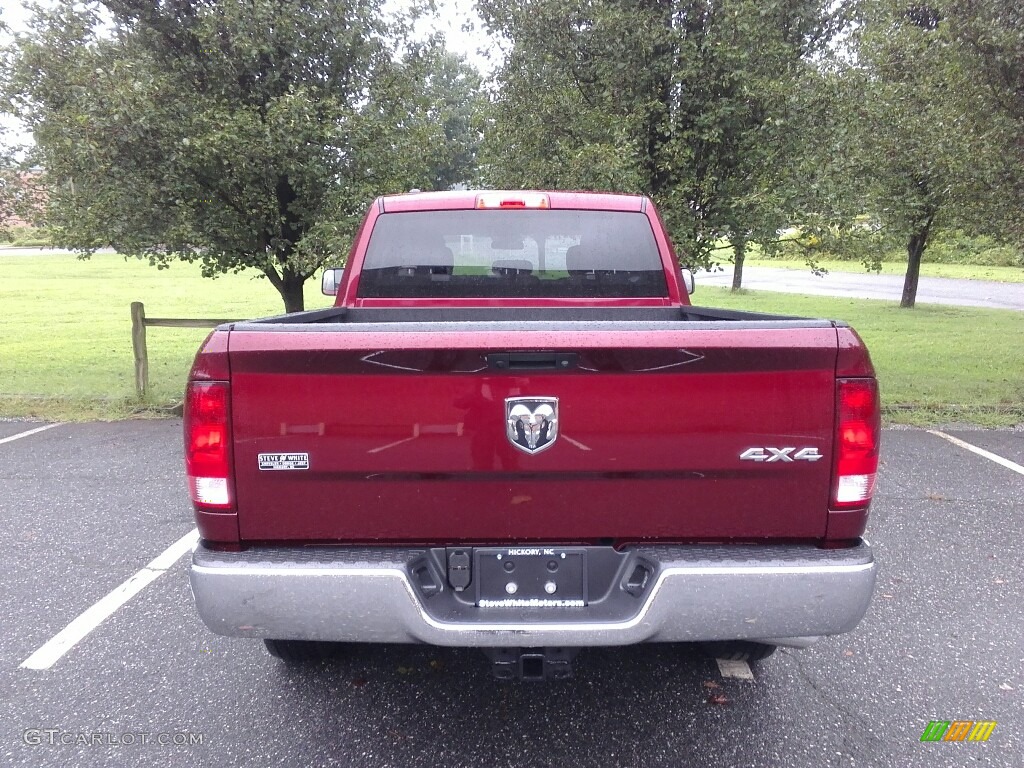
left=4, top=0, right=475, bottom=311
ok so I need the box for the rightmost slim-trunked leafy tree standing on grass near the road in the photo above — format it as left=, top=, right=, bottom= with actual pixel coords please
left=818, top=0, right=1006, bottom=307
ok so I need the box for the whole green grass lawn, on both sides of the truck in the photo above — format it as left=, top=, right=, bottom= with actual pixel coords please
left=0, top=253, right=1024, bottom=425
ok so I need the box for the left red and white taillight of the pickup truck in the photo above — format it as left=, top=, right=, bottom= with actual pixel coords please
left=184, top=381, right=232, bottom=509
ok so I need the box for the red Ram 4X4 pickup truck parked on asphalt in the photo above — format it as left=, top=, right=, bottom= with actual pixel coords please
left=184, top=191, right=880, bottom=680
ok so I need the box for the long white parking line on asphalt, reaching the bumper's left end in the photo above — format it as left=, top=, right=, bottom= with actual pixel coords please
left=20, top=528, right=199, bottom=670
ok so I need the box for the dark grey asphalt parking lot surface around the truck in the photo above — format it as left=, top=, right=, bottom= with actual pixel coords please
left=0, top=421, right=1024, bottom=768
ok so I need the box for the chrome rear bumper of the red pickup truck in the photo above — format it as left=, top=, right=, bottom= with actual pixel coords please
left=189, top=542, right=876, bottom=647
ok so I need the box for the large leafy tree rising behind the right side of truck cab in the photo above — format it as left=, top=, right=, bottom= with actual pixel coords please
left=477, top=0, right=834, bottom=281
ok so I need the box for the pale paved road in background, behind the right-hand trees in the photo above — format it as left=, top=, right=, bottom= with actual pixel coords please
left=694, top=266, right=1024, bottom=311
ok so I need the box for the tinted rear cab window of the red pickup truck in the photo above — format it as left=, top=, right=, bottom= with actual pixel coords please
left=357, top=209, right=669, bottom=298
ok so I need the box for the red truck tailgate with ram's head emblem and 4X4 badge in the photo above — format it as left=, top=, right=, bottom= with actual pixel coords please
left=228, top=322, right=837, bottom=544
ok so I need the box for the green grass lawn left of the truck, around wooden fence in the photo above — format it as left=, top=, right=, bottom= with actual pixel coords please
left=0, top=253, right=333, bottom=419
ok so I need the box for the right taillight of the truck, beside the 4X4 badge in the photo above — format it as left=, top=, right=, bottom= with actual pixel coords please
left=831, top=379, right=882, bottom=509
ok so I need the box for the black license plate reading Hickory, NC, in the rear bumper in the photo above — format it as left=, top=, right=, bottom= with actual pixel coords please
left=473, top=547, right=587, bottom=608
